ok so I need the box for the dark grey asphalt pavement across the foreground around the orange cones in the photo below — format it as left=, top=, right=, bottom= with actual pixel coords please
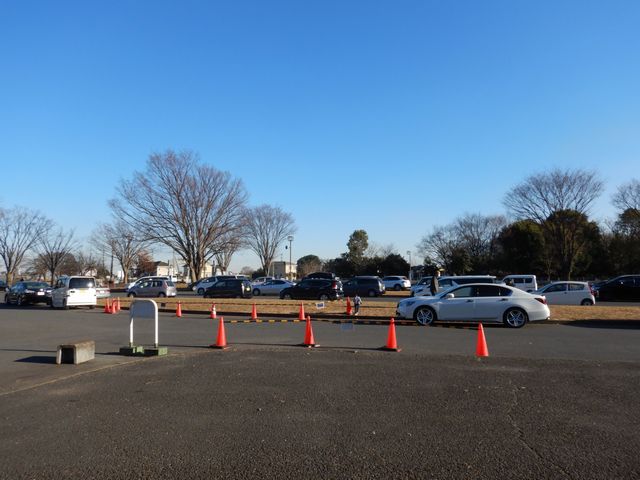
left=0, top=307, right=640, bottom=479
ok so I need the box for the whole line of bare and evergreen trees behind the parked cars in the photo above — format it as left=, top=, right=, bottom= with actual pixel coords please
left=0, top=156, right=640, bottom=283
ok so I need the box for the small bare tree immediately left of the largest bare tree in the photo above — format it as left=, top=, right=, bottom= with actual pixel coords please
left=92, top=220, right=149, bottom=283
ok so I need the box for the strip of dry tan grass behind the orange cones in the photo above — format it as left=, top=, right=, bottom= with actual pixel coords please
left=99, top=297, right=640, bottom=321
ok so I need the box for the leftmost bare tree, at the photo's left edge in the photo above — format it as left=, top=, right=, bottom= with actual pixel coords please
left=0, top=207, right=52, bottom=284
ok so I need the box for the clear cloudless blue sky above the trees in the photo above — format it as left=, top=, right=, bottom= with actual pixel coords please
left=0, top=0, right=640, bottom=270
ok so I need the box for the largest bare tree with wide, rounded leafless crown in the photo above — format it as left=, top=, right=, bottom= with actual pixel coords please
left=110, top=150, right=247, bottom=282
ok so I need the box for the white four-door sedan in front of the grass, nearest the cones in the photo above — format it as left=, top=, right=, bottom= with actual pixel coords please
left=396, top=283, right=551, bottom=328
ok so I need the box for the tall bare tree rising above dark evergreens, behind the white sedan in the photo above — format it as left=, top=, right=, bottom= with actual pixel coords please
left=503, top=170, right=604, bottom=279
